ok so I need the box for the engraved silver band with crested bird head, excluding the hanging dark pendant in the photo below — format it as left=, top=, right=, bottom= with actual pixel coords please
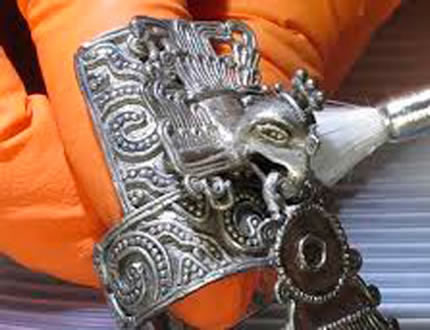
left=76, top=18, right=322, bottom=328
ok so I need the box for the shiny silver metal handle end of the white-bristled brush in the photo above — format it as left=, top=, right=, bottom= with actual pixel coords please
left=379, top=89, right=430, bottom=141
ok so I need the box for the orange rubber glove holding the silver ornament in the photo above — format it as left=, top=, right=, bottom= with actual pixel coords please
left=0, top=0, right=400, bottom=329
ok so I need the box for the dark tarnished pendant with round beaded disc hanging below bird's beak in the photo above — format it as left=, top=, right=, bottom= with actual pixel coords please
left=274, top=202, right=398, bottom=330
